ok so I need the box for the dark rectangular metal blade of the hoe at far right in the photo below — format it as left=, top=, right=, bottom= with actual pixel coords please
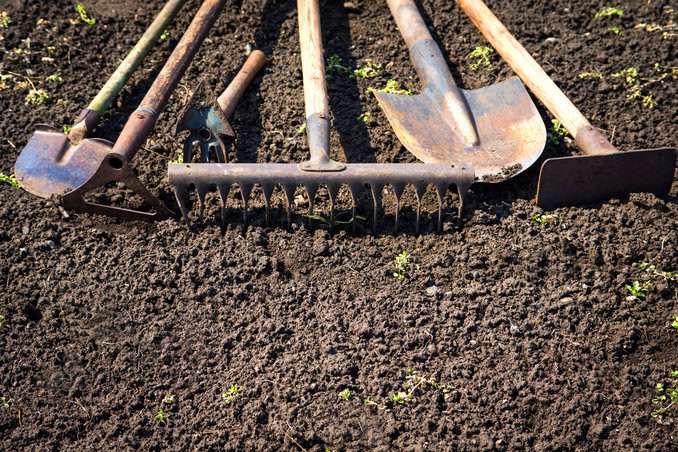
left=537, top=148, right=676, bottom=210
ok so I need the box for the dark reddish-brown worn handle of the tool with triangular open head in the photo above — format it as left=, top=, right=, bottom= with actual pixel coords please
left=112, top=0, right=226, bottom=160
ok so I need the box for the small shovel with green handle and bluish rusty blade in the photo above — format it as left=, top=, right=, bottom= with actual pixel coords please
left=15, top=0, right=186, bottom=215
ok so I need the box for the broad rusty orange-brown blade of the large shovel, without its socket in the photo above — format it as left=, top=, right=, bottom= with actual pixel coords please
left=375, top=77, right=546, bottom=182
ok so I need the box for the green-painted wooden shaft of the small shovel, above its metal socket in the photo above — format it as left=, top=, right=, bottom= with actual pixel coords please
left=87, top=0, right=186, bottom=114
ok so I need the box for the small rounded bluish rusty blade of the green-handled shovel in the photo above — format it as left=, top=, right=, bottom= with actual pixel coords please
left=14, top=127, right=111, bottom=198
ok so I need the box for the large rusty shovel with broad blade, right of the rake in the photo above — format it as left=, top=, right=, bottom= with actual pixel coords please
left=374, top=0, right=546, bottom=182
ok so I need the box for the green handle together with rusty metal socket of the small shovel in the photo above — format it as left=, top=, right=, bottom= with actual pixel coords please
left=68, top=0, right=186, bottom=144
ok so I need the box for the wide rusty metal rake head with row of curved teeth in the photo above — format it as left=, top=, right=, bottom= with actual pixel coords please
left=169, top=163, right=475, bottom=232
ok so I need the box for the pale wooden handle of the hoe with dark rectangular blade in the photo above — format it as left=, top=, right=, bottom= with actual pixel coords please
left=457, top=0, right=618, bottom=154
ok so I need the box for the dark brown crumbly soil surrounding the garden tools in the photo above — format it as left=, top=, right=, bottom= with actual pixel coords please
left=0, top=0, right=678, bottom=450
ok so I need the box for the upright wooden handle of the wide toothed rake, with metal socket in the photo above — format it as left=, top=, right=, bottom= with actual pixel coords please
left=297, top=0, right=330, bottom=163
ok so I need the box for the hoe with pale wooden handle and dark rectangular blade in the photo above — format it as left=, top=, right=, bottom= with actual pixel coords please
left=457, top=0, right=676, bottom=209
